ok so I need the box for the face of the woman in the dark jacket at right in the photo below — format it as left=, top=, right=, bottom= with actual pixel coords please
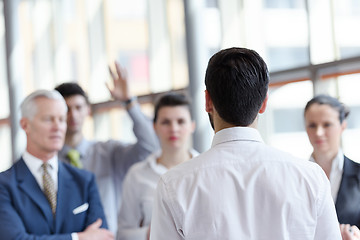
left=305, top=103, right=346, bottom=153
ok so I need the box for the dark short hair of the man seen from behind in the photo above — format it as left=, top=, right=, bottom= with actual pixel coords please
left=205, top=48, right=269, bottom=127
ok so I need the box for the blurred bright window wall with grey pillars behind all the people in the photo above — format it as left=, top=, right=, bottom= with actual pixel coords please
left=0, top=0, right=360, bottom=171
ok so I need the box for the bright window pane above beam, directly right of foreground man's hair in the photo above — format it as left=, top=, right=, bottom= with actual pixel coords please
left=263, top=0, right=310, bottom=71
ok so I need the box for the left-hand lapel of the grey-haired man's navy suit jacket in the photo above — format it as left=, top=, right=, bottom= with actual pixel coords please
left=15, top=158, right=54, bottom=231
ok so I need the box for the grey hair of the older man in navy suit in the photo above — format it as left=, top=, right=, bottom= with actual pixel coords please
left=20, top=90, right=67, bottom=119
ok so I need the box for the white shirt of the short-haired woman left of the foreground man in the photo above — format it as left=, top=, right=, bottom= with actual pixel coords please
left=117, top=149, right=199, bottom=240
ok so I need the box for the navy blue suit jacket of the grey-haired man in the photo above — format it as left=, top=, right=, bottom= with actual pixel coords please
left=0, top=158, right=107, bottom=240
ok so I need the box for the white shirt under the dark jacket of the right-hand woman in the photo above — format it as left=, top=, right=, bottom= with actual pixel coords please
left=310, top=149, right=344, bottom=203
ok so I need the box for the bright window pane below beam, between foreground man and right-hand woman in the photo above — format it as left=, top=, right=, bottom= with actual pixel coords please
left=259, top=81, right=313, bottom=158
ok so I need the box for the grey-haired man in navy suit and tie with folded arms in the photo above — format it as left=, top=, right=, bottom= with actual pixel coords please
left=0, top=90, right=114, bottom=240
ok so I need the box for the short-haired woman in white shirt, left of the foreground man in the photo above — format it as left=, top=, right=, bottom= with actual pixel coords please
left=117, top=93, right=198, bottom=240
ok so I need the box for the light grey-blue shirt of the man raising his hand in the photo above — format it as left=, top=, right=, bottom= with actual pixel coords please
left=59, top=104, right=159, bottom=234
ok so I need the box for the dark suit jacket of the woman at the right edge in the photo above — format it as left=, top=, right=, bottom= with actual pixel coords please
left=335, top=156, right=360, bottom=228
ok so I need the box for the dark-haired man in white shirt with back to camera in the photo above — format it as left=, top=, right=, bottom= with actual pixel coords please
left=150, top=48, right=341, bottom=240
